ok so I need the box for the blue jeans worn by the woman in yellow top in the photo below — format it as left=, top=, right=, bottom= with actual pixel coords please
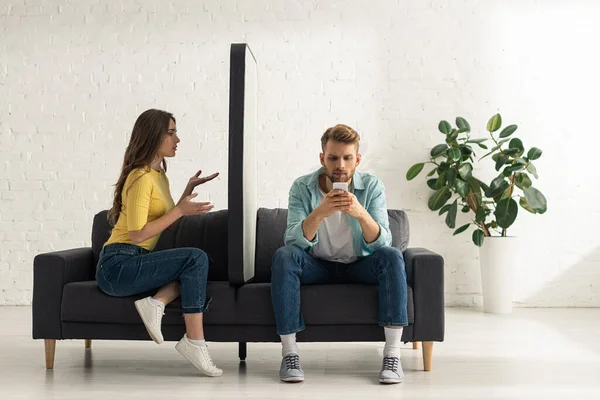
left=96, top=243, right=210, bottom=314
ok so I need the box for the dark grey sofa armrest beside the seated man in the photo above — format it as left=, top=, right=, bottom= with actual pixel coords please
left=404, top=248, right=445, bottom=342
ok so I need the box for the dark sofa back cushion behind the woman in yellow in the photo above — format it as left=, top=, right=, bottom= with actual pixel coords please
left=92, top=210, right=228, bottom=281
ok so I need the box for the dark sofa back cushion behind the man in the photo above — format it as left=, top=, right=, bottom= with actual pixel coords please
left=254, top=208, right=410, bottom=282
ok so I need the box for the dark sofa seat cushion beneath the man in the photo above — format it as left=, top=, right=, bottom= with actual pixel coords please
left=235, top=283, right=415, bottom=325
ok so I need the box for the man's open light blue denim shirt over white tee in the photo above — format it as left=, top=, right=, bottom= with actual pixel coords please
left=284, top=168, right=392, bottom=257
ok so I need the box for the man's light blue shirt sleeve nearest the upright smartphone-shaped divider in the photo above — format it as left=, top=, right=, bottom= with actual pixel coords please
left=284, top=182, right=319, bottom=251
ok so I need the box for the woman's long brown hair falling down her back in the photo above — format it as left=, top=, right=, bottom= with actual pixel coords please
left=108, top=109, right=176, bottom=225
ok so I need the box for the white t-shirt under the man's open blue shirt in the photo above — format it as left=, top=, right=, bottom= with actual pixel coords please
left=312, top=187, right=357, bottom=264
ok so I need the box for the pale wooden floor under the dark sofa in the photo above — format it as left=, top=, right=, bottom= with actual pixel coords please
left=0, top=307, right=600, bottom=400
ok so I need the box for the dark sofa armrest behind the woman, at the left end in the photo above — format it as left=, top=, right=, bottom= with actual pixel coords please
left=32, top=247, right=95, bottom=339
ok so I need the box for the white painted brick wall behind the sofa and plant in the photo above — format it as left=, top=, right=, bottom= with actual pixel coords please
left=0, top=0, right=600, bottom=306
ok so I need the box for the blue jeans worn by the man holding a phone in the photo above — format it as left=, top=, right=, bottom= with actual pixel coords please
left=271, top=246, right=408, bottom=335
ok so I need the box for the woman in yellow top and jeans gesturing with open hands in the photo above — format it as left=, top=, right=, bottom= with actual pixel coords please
left=96, top=109, right=223, bottom=376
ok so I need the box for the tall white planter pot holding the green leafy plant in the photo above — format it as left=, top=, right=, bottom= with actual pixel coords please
left=479, top=237, right=516, bottom=314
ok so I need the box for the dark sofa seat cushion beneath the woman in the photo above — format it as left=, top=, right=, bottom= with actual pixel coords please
left=61, top=281, right=235, bottom=325
